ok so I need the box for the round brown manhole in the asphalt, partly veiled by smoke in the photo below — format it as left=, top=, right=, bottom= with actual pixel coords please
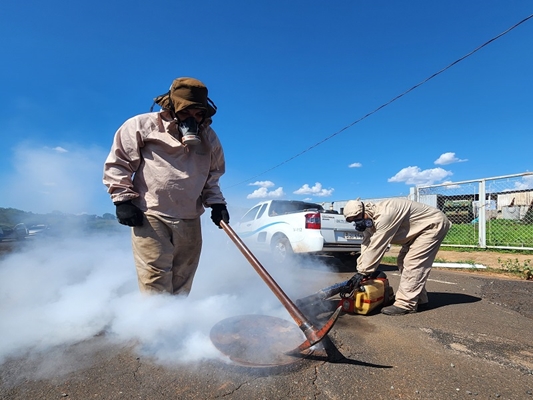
left=210, top=315, right=313, bottom=367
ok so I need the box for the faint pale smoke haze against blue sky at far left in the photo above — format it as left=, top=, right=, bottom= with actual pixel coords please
left=0, top=143, right=109, bottom=215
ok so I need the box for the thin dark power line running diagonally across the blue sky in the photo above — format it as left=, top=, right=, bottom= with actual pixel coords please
left=228, top=14, right=533, bottom=189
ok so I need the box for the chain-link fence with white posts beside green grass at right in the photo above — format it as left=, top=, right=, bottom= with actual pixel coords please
left=412, top=172, right=533, bottom=250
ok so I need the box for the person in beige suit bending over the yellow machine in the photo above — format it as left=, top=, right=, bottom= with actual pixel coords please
left=343, top=199, right=451, bottom=315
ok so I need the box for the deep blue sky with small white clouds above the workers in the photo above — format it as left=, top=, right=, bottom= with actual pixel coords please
left=0, top=0, right=533, bottom=215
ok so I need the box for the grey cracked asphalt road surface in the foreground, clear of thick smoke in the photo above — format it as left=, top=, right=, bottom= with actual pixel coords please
left=0, top=264, right=533, bottom=400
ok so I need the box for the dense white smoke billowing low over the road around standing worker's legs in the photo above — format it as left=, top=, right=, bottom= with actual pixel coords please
left=0, top=223, right=332, bottom=375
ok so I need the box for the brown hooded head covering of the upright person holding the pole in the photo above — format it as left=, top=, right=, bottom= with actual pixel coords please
left=154, top=78, right=217, bottom=118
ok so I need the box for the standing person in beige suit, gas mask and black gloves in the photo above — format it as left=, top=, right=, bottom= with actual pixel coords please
left=103, top=78, right=229, bottom=295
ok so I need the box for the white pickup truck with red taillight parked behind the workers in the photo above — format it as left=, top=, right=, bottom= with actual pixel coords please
left=234, top=200, right=363, bottom=263
